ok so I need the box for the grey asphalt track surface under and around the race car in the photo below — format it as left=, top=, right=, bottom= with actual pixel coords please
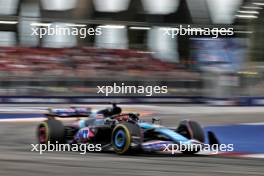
left=0, top=107, right=264, bottom=176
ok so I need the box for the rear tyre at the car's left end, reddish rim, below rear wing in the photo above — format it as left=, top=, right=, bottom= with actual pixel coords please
left=37, top=119, right=64, bottom=144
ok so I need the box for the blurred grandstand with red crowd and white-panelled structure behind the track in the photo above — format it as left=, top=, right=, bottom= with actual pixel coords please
left=0, top=0, right=264, bottom=98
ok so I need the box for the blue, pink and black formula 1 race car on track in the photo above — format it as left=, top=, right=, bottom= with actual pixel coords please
left=37, top=104, right=205, bottom=154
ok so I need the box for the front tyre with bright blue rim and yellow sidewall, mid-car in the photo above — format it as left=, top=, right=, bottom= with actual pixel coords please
left=111, top=123, right=141, bottom=154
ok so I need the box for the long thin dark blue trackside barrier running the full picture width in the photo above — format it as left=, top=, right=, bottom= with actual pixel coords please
left=0, top=96, right=264, bottom=106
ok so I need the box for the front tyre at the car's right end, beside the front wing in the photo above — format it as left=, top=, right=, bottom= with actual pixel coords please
left=176, top=120, right=205, bottom=154
